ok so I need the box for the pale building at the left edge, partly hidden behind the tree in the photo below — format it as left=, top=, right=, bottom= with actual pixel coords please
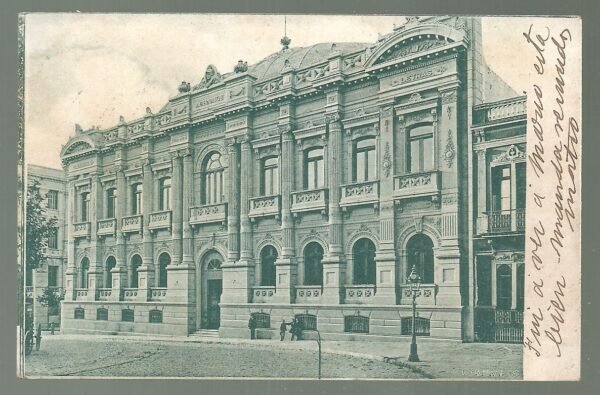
left=25, top=164, right=67, bottom=329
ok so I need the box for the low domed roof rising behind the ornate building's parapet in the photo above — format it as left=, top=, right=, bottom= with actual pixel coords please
left=248, top=43, right=370, bottom=81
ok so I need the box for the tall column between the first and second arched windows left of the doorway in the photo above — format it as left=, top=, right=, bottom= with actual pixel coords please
left=132, top=159, right=155, bottom=302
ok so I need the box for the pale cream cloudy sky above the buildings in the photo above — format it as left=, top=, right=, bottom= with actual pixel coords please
left=25, top=13, right=531, bottom=168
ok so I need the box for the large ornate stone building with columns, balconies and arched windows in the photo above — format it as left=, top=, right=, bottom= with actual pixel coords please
left=61, top=17, right=520, bottom=341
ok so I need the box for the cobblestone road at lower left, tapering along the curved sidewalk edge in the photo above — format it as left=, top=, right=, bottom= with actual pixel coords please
left=25, top=336, right=422, bottom=379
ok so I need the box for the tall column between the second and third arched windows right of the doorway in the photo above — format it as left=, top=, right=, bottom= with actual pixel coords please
left=321, top=112, right=345, bottom=304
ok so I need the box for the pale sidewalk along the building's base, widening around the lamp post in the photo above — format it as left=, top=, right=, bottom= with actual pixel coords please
left=44, top=334, right=523, bottom=380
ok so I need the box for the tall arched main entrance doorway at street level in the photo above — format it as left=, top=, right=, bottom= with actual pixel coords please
left=198, top=251, right=223, bottom=329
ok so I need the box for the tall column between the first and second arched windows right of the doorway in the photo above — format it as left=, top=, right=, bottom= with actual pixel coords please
left=275, top=124, right=296, bottom=304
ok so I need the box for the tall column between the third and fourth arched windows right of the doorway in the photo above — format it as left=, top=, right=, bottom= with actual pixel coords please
left=373, top=106, right=396, bottom=305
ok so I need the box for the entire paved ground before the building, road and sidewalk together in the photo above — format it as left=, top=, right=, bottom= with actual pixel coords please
left=25, top=334, right=522, bottom=380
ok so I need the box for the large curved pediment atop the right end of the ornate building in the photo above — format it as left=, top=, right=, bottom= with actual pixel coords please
left=365, top=23, right=467, bottom=69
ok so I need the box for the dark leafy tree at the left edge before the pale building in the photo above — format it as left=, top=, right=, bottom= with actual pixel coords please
left=25, top=179, right=57, bottom=273
